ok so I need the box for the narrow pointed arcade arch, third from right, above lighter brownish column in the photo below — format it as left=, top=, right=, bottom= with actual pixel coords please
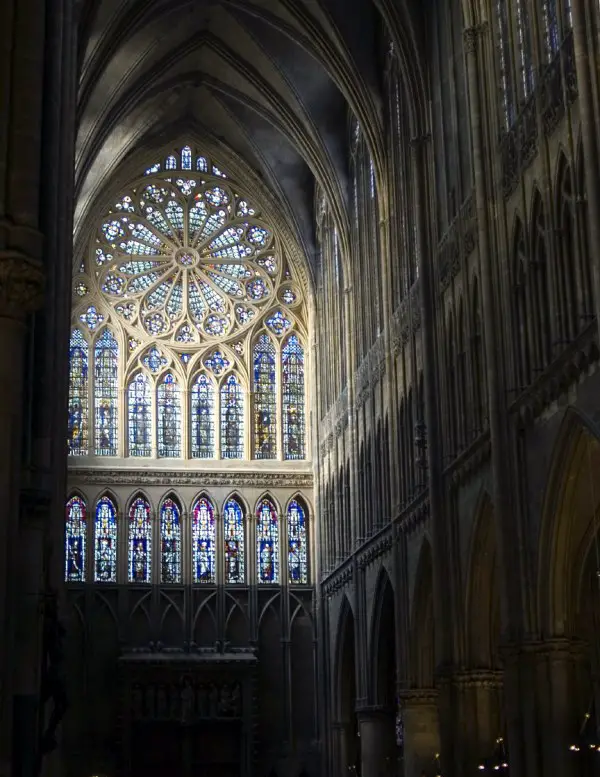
left=409, top=537, right=435, bottom=688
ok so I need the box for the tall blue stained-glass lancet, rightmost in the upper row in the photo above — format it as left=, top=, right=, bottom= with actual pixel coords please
left=281, top=335, right=305, bottom=459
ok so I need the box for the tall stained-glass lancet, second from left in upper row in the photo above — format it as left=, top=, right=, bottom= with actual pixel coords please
left=94, top=329, right=119, bottom=456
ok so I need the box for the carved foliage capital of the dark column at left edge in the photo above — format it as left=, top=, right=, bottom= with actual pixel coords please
left=0, top=251, right=44, bottom=319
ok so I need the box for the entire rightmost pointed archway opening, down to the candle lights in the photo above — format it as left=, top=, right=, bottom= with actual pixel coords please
left=536, top=408, right=600, bottom=775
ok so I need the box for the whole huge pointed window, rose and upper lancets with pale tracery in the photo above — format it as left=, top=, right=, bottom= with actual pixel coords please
left=68, top=145, right=306, bottom=459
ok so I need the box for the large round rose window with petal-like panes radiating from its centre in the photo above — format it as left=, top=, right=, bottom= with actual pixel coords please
left=93, top=173, right=284, bottom=343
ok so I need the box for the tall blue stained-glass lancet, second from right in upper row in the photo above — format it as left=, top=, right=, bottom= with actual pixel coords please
left=254, top=334, right=277, bottom=459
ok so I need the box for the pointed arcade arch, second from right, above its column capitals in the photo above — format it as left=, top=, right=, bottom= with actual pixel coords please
left=465, top=492, right=500, bottom=669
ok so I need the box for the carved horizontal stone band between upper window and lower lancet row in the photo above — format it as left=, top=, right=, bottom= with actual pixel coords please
left=69, top=469, right=313, bottom=489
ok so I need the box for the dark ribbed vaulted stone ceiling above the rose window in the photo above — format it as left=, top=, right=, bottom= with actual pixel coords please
left=75, top=0, right=422, bottom=272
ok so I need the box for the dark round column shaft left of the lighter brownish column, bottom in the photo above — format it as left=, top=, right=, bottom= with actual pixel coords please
left=358, top=707, right=396, bottom=777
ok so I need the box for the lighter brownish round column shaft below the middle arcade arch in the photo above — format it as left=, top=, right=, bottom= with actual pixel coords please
left=400, top=688, right=440, bottom=777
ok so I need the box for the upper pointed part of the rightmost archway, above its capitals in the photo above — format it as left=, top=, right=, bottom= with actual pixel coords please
left=538, top=406, right=600, bottom=636
